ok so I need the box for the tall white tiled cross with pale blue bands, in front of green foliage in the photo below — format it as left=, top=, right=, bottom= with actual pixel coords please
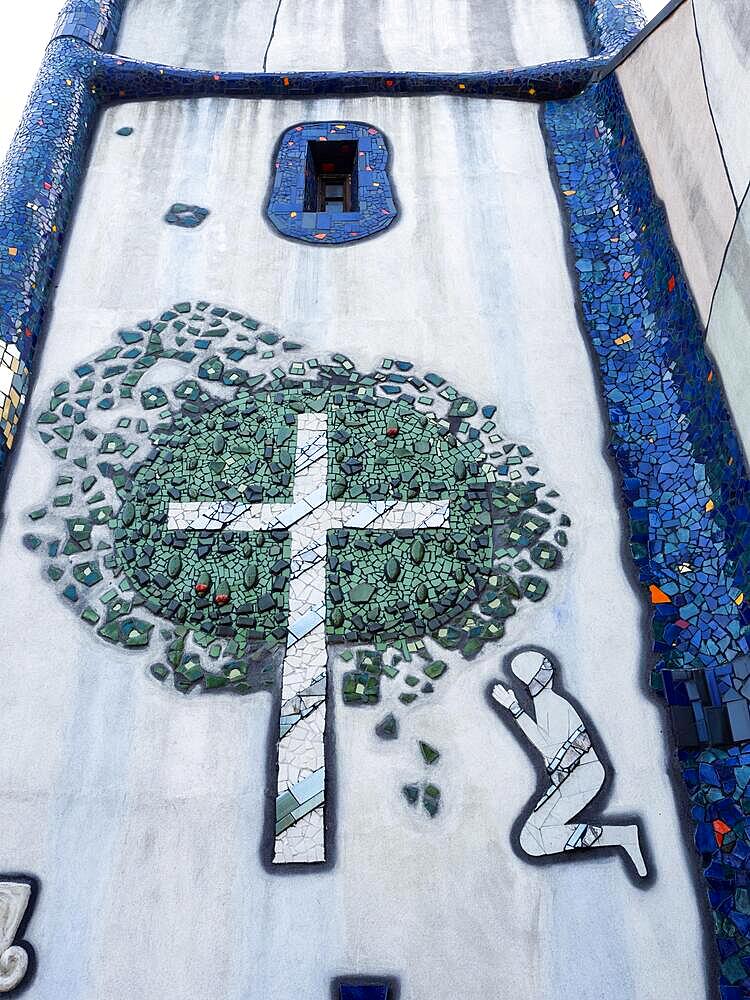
left=168, top=413, right=449, bottom=864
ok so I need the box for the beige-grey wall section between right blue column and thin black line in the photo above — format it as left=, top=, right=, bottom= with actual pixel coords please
left=617, top=3, right=736, bottom=322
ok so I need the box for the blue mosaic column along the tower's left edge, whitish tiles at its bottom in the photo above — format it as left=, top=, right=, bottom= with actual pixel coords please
left=0, top=0, right=125, bottom=460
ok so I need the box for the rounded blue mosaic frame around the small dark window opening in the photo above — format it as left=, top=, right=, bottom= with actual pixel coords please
left=266, top=121, right=398, bottom=246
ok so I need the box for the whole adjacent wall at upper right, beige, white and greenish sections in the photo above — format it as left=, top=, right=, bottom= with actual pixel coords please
left=617, top=0, right=750, bottom=452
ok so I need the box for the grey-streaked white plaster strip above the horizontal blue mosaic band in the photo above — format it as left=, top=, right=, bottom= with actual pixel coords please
left=118, top=0, right=587, bottom=72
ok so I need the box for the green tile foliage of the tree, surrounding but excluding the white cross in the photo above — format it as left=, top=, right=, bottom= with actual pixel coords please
left=27, top=302, right=570, bottom=701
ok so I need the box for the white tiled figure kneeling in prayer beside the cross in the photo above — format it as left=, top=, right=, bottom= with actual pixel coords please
left=492, top=650, right=648, bottom=877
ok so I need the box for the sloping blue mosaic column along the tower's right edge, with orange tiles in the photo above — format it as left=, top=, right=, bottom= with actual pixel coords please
left=544, top=76, right=750, bottom=1000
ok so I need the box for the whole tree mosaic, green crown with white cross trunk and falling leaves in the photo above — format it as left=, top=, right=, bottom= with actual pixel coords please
left=24, top=302, right=570, bottom=864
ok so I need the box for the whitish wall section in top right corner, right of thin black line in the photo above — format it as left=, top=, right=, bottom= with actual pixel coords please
left=693, top=0, right=750, bottom=201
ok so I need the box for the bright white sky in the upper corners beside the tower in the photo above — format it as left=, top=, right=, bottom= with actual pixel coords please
left=0, top=0, right=666, bottom=166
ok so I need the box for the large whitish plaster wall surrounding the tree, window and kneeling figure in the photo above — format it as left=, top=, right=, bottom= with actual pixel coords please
left=0, top=98, right=707, bottom=1000
